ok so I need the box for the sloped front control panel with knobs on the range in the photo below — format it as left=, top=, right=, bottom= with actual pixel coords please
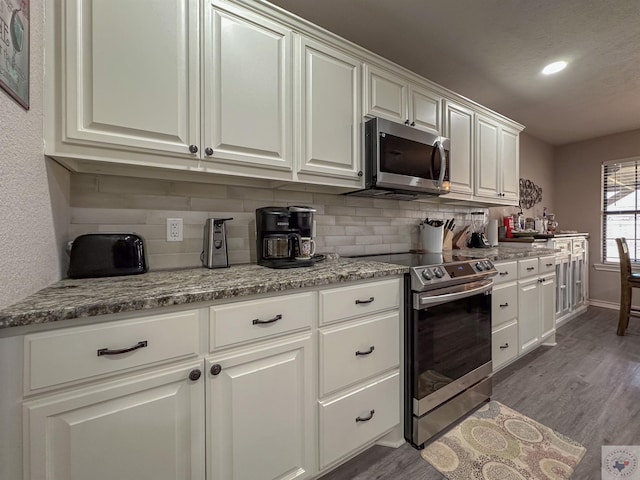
left=411, top=258, right=498, bottom=291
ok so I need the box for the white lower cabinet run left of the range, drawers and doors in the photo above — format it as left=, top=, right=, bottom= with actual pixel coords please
left=13, top=278, right=401, bottom=480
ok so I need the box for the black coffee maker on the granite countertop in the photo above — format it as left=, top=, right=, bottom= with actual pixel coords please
left=256, top=206, right=315, bottom=268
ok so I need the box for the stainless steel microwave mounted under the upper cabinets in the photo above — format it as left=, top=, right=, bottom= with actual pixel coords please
left=349, top=118, right=450, bottom=200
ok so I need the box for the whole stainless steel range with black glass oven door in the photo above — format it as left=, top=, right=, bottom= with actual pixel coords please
left=344, top=253, right=497, bottom=448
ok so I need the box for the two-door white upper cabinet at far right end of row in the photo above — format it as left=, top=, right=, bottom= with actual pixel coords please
left=475, top=115, right=519, bottom=205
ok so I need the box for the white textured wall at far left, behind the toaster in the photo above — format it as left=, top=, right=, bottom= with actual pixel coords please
left=0, top=1, right=69, bottom=308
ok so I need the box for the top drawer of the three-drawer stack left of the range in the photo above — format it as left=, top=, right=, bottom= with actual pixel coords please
left=320, top=279, right=400, bottom=324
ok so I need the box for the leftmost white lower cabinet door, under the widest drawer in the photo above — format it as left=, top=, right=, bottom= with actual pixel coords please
left=23, top=361, right=205, bottom=480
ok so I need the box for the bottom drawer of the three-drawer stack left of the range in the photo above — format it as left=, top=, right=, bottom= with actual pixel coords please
left=319, top=372, right=400, bottom=469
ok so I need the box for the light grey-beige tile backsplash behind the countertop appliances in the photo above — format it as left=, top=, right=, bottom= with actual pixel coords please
left=69, top=174, right=487, bottom=270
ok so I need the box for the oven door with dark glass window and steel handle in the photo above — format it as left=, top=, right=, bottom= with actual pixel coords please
left=407, top=280, right=493, bottom=416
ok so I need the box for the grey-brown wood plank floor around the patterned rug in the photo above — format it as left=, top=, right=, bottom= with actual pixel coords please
left=322, top=307, right=640, bottom=480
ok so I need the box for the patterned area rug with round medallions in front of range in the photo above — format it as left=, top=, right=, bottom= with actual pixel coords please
left=422, top=402, right=586, bottom=480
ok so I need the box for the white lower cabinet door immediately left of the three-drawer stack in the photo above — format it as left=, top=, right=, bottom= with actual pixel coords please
left=207, top=334, right=315, bottom=480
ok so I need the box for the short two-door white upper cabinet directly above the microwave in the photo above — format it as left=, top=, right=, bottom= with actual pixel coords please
left=365, top=65, right=441, bottom=132
